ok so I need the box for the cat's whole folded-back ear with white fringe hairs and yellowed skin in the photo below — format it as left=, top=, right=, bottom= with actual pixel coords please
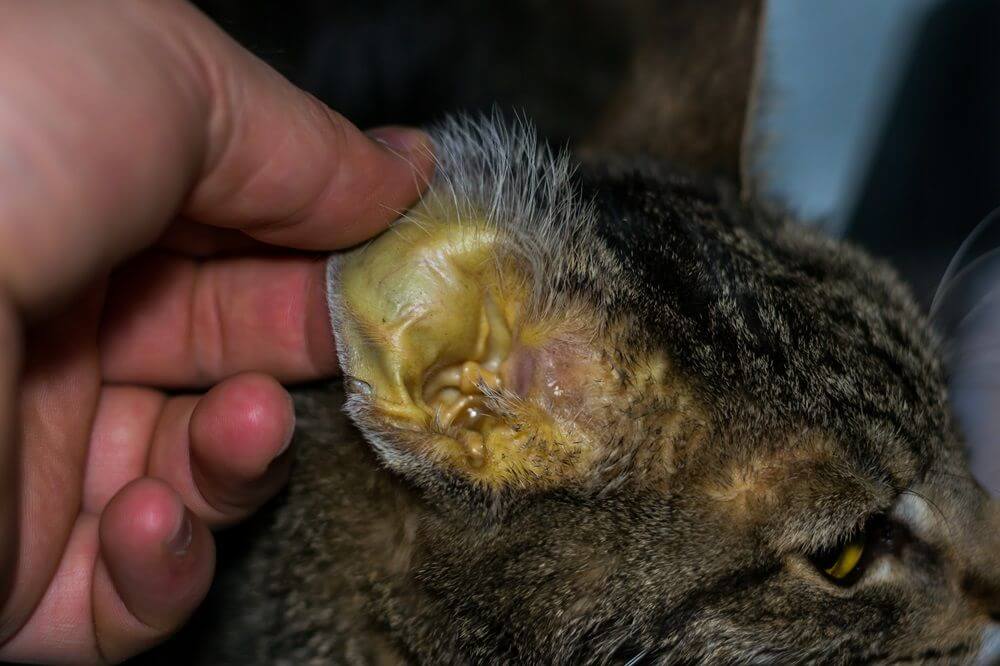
left=328, top=118, right=700, bottom=490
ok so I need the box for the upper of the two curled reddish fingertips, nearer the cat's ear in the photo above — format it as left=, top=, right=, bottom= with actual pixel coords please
left=148, top=374, right=295, bottom=527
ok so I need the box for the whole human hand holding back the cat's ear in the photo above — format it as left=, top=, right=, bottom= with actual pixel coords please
left=0, top=0, right=433, bottom=664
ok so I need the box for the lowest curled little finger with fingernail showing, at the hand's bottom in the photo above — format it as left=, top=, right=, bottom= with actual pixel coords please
left=93, top=478, right=215, bottom=662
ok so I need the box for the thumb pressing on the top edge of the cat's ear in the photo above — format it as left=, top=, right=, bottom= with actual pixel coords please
left=165, top=3, right=433, bottom=250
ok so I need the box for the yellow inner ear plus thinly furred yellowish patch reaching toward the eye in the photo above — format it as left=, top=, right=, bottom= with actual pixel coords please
left=328, top=201, right=702, bottom=491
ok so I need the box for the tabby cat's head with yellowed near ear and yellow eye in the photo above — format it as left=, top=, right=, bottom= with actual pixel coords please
left=329, top=119, right=1000, bottom=664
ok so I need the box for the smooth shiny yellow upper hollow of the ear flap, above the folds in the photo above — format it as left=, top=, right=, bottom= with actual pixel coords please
left=339, top=214, right=504, bottom=421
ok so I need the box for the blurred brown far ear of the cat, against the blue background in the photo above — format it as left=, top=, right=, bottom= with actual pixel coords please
left=581, top=0, right=765, bottom=192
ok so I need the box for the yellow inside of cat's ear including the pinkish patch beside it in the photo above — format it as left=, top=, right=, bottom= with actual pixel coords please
left=329, top=195, right=609, bottom=487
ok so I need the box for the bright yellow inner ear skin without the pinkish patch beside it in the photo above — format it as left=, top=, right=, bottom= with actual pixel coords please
left=333, top=208, right=596, bottom=487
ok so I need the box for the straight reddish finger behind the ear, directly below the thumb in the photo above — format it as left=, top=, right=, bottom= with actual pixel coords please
left=100, top=253, right=337, bottom=387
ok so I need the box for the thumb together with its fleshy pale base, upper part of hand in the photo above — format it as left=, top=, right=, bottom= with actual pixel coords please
left=0, top=0, right=433, bottom=312
